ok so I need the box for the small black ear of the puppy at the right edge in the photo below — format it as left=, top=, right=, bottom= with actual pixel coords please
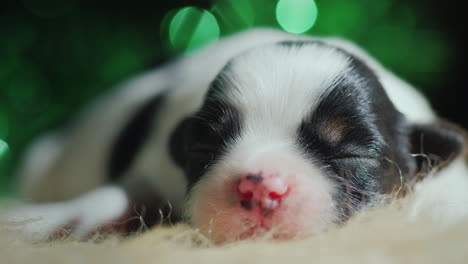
left=410, top=121, right=466, bottom=171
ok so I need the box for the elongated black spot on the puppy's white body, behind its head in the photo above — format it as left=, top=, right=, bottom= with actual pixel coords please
left=108, top=94, right=164, bottom=181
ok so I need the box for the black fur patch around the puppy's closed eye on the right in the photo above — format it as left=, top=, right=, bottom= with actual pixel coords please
left=291, top=47, right=404, bottom=220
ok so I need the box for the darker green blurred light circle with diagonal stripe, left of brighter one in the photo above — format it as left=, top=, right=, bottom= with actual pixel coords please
left=169, top=7, right=220, bottom=53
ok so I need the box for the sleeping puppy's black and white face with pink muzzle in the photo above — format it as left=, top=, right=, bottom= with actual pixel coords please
left=171, top=42, right=464, bottom=242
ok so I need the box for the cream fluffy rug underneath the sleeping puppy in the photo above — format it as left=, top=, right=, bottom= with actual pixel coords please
left=0, top=158, right=468, bottom=264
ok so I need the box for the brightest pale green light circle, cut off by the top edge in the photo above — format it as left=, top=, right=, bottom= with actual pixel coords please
left=276, top=0, right=318, bottom=34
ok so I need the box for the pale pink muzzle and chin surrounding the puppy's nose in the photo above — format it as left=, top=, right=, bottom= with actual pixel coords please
left=185, top=157, right=337, bottom=243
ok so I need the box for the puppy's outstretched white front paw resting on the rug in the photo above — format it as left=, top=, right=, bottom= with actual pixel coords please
left=1, top=186, right=128, bottom=241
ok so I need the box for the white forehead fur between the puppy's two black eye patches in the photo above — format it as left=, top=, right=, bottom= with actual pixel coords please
left=222, top=45, right=349, bottom=134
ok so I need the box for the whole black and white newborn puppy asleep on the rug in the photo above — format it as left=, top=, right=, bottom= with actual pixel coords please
left=4, top=29, right=464, bottom=242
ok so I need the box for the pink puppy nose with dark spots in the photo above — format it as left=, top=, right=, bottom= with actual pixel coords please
left=237, top=173, right=289, bottom=210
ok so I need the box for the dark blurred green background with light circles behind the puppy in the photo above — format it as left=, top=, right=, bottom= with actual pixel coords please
left=0, top=0, right=468, bottom=194
